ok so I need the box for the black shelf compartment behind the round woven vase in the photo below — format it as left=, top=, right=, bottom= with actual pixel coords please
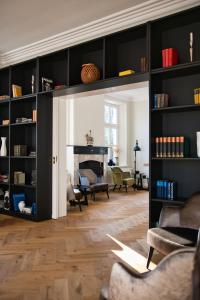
left=69, top=39, right=103, bottom=86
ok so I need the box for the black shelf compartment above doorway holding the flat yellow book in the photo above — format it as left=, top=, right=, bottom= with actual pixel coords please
left=105, top=25, right=148, bottom=78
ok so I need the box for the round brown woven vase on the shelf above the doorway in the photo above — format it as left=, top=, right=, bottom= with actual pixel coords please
left=81, top=64, right=100, bottom=83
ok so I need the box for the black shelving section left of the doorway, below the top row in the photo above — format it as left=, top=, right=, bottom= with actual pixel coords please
left=0, top=94, right=52, bottom=221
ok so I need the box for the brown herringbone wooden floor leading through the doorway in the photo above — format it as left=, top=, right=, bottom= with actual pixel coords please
left=0, top=191, right=148, bottom=300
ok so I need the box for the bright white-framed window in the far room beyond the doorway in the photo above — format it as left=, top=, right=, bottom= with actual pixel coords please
left=104, top=102, right=119, bottom=146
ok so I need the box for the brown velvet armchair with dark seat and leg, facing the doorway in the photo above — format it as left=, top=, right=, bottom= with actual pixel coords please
left=147, top=192, right=200, bottom=268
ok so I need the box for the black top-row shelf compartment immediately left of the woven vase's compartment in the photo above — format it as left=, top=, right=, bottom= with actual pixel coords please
left=39, top=49, right=68, bottom=92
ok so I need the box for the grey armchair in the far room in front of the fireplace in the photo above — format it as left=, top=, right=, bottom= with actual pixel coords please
left=78, top=169, right=109, bottom=202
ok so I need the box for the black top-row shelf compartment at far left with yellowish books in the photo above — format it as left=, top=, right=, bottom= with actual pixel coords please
left=11, top=59, right=37, bottom=99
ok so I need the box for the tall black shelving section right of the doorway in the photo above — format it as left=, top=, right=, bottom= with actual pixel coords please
left=149, top=7, right=200, bottom=227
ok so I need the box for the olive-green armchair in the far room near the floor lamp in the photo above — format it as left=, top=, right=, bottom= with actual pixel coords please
left=111, top=167, right=135, bottom=192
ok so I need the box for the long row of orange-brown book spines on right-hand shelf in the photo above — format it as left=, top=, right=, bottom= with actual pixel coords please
left=155, top=136, right=189, bottom=157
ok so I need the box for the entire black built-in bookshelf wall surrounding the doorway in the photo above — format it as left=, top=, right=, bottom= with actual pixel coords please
left=0, top=6, right=200, bottom=221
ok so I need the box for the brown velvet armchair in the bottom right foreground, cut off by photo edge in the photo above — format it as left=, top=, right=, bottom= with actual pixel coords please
left=100, top=241, right=200, bottom=300
